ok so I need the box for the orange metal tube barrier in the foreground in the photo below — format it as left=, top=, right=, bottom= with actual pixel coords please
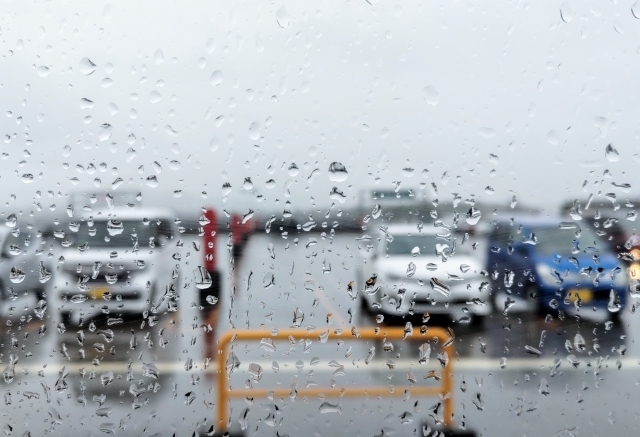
left=217, top=327, right=454, bottom=431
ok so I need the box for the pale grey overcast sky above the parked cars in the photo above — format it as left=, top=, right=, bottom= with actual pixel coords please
left=0, top=0, right=640, bottom=220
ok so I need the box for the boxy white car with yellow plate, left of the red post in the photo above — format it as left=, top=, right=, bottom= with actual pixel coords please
left=47, top=209, right=180, bottom=326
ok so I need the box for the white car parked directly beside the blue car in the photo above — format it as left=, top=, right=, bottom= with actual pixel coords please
left=358, top=225, right=492, bottom=322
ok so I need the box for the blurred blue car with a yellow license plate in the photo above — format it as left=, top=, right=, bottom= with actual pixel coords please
left=487, top=217, right=628, bottom=318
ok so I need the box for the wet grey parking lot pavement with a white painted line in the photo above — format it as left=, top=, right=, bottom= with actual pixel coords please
left=3, top=216, right=640, bottom=435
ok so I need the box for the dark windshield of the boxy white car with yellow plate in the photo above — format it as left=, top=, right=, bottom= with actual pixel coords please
left=75, top=220, right=170, bottom=248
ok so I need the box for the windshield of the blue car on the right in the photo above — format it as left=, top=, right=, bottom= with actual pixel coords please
left=527, top=226, right=607, bottom=255
